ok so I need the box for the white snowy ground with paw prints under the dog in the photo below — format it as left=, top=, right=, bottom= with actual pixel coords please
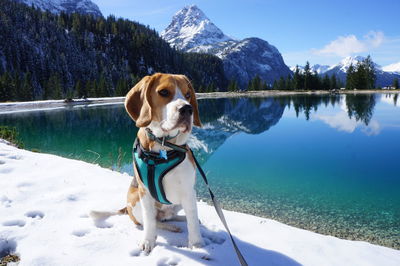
left=0, top=140, right=400, bottom=266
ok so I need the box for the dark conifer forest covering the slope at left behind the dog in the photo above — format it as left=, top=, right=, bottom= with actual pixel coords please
left=0, top=0, right=227, bottom=101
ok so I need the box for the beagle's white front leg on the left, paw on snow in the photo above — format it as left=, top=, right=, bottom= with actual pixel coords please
left=140, top=192, right=157, bottom=253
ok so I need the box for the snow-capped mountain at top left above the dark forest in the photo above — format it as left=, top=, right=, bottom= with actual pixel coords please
left=17, top=0, right=102, bottom=16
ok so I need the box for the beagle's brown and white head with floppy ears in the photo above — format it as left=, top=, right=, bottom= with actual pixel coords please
left=125, top=73, right=201, bottom=138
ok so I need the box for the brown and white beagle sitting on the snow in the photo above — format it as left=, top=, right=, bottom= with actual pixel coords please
left=125, top=73, right=204, bottom=253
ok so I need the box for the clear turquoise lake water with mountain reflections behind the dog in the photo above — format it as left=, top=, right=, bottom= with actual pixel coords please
left=0, top=94, right=400, bottom=249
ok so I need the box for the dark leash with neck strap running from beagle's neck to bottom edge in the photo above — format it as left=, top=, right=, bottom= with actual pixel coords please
left=146, top=128, right=248, bottom=266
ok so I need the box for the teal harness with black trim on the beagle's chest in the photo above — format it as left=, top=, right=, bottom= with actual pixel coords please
left=132, top=134, right=186, bottom=204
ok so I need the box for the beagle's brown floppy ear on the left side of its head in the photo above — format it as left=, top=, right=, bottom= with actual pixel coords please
left=125, top=76, right=153, bottom=127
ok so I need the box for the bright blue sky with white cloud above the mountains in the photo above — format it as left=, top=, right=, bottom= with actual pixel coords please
left=92, top=0, right=400, bottom=66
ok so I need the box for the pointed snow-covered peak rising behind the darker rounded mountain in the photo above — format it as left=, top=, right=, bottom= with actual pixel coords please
left=161, top=5, right=232, bottom=51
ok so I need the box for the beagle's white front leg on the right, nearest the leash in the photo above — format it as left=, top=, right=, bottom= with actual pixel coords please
left=182, top=189, right=204, bottom=248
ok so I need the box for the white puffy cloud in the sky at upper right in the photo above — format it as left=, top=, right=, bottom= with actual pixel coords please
left=314, top=31, right=385, bottom=57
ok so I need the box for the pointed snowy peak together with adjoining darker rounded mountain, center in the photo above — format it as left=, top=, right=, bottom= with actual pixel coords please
left=161, top=5, right=292, bottom=89
